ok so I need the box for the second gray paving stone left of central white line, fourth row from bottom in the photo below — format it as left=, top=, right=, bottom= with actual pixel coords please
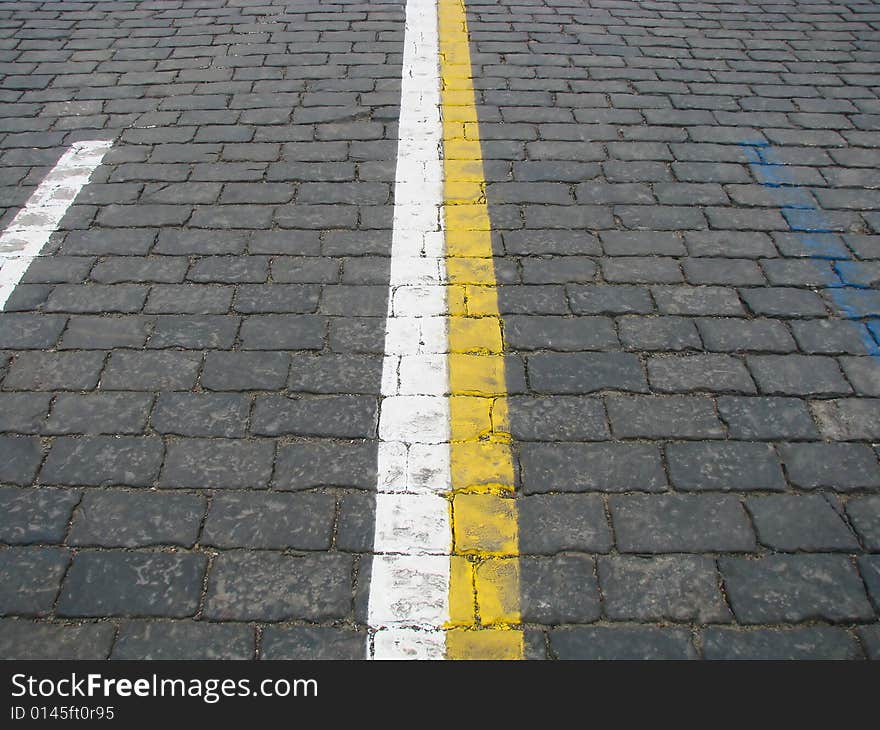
left=159, top=439, right=275, bottom=489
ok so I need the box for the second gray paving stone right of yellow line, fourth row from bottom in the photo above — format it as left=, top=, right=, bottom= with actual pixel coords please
left=666, top=441, right=785, bottom=492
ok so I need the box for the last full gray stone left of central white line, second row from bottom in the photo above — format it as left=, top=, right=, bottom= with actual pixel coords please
left=204, top=551, right=352, bottom=621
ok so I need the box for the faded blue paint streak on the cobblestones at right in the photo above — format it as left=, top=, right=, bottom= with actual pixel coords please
left=740, top=140, right=880, bottom=363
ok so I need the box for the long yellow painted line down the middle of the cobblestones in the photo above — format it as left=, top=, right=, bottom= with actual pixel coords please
left=438, top=0, right=523, bottom=659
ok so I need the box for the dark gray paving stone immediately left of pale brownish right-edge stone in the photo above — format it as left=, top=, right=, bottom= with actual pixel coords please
left=717, top=396, right=818, bottom=441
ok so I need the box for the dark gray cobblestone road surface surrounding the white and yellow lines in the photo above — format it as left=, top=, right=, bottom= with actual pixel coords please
left=0, top=0, right=880, bottom=659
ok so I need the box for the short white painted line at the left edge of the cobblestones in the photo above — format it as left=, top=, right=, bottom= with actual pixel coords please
left=0, top=140, right=113, bottom=310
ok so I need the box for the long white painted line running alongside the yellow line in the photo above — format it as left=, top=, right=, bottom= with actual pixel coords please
left=367, top=0, right=451, bottom=659
